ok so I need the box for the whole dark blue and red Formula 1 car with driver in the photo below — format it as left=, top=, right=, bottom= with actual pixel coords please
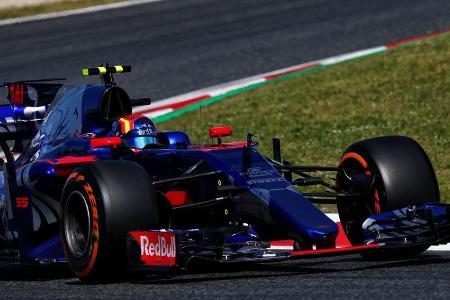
left=0, top=66, right=450, bottom=281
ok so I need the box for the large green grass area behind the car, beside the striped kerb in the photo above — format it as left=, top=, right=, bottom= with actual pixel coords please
left=159, top=35, right=450, bottom=202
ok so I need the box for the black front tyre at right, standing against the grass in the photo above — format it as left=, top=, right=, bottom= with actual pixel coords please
left=336, top=136, right=439, bottom=259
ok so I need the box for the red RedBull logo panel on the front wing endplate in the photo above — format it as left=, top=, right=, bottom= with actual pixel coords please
left=130, top=231, right=177, bottom=266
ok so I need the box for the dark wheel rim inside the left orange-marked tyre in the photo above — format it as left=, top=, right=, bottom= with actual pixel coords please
left=64, top=191, right=91, bottom=258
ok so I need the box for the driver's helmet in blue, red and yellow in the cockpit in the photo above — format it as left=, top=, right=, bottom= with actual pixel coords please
left=113, top=114, right=158, bottom=149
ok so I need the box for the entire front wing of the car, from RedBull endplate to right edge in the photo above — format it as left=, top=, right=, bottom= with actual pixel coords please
left=127, top=204, right=450, bottom=268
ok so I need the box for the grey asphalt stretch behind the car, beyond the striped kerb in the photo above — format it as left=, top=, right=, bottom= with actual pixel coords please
left=0, top=0, right=450, bottom=99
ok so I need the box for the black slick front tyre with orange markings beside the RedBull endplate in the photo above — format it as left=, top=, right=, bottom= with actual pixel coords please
left=60, top=161, right=158, bottom=282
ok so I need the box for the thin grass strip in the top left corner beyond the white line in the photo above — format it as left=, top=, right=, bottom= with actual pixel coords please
left=0, top=0, right=123, bottom=19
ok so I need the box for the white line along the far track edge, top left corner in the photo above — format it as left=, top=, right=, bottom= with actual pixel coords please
left=0, top=0, right=167, bottom=26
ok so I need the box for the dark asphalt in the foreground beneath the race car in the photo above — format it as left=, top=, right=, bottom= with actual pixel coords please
left=0, top=252, right=450, bottom=299
